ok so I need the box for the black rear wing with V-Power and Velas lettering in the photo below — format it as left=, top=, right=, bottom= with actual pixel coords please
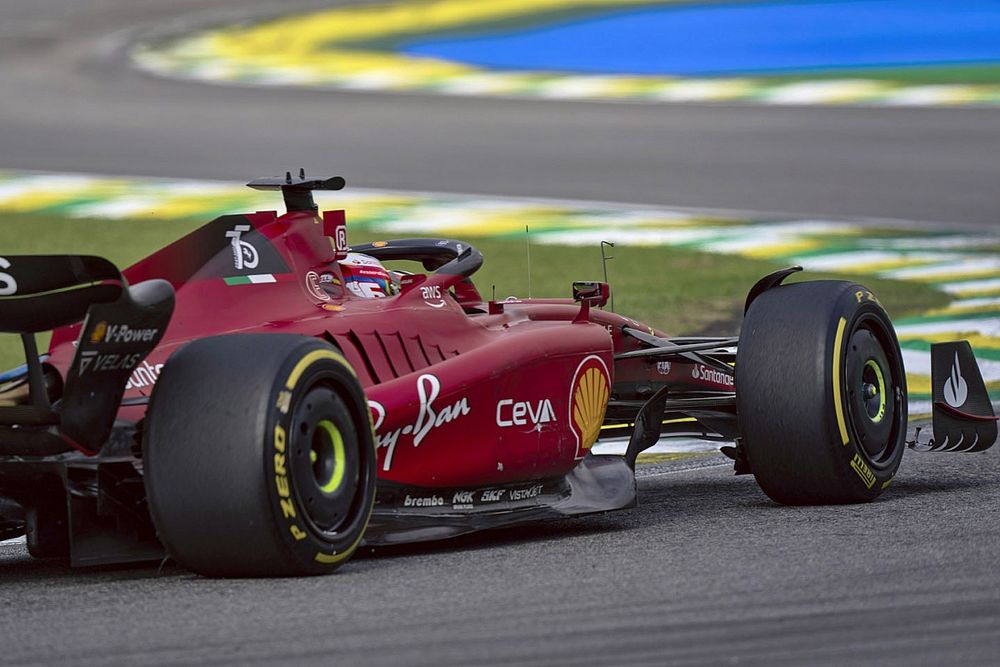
left=0, top=255, right=174, bottom=456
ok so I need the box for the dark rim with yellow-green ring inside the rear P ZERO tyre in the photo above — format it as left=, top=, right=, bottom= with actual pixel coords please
left=290, top=385, right=364, bottom=537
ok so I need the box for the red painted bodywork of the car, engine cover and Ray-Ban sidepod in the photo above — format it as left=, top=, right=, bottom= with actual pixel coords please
left=50, top=212, right=720, bottom=488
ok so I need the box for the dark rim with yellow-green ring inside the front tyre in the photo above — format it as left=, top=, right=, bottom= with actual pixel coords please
left=845, top=315, right=906, bottom=468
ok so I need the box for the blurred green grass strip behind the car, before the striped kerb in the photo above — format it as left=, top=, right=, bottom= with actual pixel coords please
left=0, top=215, right=949, bottom=369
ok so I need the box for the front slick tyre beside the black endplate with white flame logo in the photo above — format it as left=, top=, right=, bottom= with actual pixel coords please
left=736, top=281, right=907, bottom=505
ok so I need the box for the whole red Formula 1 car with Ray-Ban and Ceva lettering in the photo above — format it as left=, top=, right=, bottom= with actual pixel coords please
left=0, top=174, right=997, bottom=575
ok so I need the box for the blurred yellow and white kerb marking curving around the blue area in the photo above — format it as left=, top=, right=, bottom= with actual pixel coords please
left=131, top=0, right=1000, bottom=106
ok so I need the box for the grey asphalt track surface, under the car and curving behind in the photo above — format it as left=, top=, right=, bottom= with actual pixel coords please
left=0, top=0, right=1000, bottom=665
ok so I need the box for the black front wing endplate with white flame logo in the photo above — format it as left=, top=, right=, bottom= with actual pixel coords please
left=930, top=340, right=997, bottom=452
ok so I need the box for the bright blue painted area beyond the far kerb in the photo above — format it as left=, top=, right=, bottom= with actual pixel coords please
left=400, top=0, right=1000, bottom=76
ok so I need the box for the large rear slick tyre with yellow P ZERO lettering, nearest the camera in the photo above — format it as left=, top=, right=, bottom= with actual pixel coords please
left=143, top=334, right=376, bottom=577
